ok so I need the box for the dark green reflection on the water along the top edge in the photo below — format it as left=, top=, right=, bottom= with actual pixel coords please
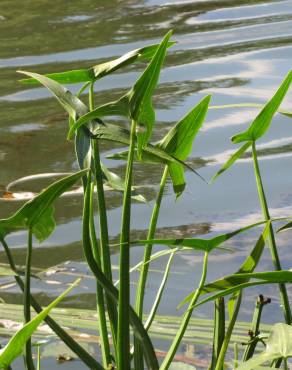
left=0, top=0, right=282, bottom=58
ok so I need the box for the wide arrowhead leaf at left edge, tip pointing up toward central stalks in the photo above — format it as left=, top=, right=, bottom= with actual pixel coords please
left=0, top=169, right=88, bottom=242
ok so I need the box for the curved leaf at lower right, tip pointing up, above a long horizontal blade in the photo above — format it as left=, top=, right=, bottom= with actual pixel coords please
left=178, top=222, right=270, bottom=308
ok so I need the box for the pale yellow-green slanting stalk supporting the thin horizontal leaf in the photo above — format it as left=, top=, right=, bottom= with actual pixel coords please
left=160, top=252, right=208, bottom=370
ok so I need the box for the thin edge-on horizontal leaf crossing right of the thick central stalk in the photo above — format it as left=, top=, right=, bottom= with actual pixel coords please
left=133, top=221, right=266, bottom=252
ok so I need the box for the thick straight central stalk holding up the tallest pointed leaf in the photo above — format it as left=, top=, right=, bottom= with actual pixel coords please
left=117, top=120, right=137, bottom=370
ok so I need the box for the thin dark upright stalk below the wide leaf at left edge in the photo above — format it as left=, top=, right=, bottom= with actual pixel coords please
left=23, top=228, right=35, bottom=370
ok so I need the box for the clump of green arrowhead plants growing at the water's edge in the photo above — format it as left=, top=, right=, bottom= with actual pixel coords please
left=0, top=31, right=292, bottom=370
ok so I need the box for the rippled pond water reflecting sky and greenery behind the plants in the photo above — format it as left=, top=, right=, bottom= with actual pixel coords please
left=0, top=0, right=292, bottom=369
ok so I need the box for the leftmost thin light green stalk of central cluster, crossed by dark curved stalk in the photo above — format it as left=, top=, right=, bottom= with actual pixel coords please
left=89, top=182, right=111, bottom=368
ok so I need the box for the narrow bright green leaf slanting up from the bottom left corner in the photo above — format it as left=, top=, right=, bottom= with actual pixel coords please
left=0, top=279, right=86, bottom=369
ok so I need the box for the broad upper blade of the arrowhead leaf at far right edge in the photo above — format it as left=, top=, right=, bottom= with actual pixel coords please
left=231, top=71, right=292, bottom=143
